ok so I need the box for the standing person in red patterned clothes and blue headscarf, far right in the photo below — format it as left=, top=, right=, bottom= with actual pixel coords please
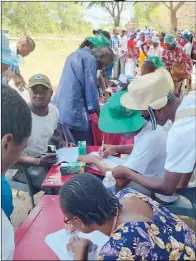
left=161, top=34, right=192, bottom=96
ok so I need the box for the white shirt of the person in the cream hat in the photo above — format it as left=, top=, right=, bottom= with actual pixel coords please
left=165, top=91, right=196, bottom=173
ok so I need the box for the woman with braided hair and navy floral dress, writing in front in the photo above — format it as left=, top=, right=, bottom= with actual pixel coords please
left=60, top=174, right=196, bottom=260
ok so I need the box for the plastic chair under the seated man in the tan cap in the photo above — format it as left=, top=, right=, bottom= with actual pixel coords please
left=6, top=164, right=40, bottom=209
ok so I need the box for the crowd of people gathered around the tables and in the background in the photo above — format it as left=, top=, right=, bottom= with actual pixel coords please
left=1, top=23, right=196, bottom=260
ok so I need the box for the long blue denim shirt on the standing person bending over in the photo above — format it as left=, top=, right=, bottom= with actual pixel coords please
left=52, top=48, right=99, bottom=131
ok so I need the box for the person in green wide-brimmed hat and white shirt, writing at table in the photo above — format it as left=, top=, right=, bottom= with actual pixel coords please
left=78, top=91, right=167, bottom=195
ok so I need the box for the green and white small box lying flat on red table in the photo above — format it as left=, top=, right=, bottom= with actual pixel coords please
left=60, top=161, right=86, bottom=175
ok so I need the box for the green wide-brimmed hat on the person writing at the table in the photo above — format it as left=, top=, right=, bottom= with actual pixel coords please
left=98, top=91, right=146, bottom=134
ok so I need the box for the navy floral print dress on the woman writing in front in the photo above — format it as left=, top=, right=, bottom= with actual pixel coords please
left=98, top=188, right=196, bottom=261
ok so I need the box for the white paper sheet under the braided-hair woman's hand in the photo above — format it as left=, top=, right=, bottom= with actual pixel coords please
left=45, top=229, right=109, bottom=260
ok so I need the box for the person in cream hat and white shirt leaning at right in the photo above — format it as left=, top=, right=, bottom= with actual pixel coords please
left=113, top=70, right=196, bottom=202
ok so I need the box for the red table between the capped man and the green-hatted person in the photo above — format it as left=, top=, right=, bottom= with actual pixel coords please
left=42, top=146, right=103, bottom=188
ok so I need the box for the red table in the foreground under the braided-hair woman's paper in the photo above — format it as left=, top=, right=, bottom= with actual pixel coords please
left=13, top=196, right=64, bottom=260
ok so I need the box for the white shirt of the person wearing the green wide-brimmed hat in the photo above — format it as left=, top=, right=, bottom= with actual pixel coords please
left=125, top=122, right=167, bottom=178
